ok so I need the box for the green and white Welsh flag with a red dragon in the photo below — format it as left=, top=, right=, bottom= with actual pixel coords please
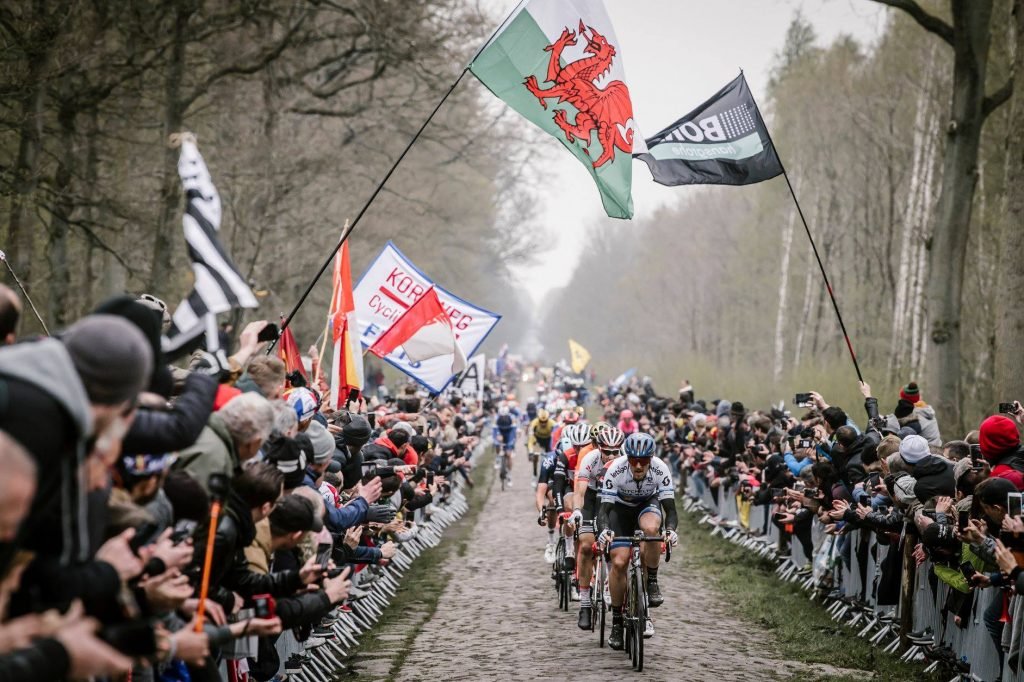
left=469, top=0, right=647, bottom=218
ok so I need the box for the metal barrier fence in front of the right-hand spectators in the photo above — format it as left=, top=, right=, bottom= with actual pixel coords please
left=683, top=475, right=1024, bottom=682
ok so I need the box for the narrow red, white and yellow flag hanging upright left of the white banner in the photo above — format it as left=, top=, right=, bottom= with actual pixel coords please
left=330, top=242, right=364, bottom=410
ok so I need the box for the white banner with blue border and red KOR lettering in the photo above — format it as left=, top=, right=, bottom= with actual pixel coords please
left=354, top=242, right=502, bottom=393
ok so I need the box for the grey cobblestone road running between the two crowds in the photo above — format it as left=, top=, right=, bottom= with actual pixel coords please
left=396, top=446, right=847, bottom=682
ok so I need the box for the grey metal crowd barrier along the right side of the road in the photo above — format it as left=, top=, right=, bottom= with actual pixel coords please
left=686, top=475, right=1024, bottom=682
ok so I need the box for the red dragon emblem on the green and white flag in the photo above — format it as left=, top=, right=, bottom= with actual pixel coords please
left=524, top=19, right=636, bottom=168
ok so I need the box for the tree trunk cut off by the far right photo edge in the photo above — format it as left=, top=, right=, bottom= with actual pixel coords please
left=994, top=0, right=1024, bottom=401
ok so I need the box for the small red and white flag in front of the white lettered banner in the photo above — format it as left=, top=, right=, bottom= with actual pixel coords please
left=370, top=287, right=466, bottom=374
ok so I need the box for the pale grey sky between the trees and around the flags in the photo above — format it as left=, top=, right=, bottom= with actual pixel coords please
left=485, top=0, right=886, bottom=300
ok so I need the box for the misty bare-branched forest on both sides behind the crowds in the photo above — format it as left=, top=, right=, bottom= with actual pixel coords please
left=0, top=0, right=1024, bottom=432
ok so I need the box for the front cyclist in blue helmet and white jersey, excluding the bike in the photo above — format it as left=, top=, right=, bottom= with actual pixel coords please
left=597, top=433, right=679, bottom=649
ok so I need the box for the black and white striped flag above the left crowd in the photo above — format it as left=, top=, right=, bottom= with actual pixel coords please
left=163, top=140, right=259, bottom=356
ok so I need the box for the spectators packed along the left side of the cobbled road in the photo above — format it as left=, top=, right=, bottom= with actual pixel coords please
left=0, top=288, right=482, bottom=682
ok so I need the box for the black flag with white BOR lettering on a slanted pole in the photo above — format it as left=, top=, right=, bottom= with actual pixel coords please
left=635, top=74, right=782, bottom=185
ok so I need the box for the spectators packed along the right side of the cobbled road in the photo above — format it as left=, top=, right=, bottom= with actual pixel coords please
left=597, top=378, right=1024, bottom=681
